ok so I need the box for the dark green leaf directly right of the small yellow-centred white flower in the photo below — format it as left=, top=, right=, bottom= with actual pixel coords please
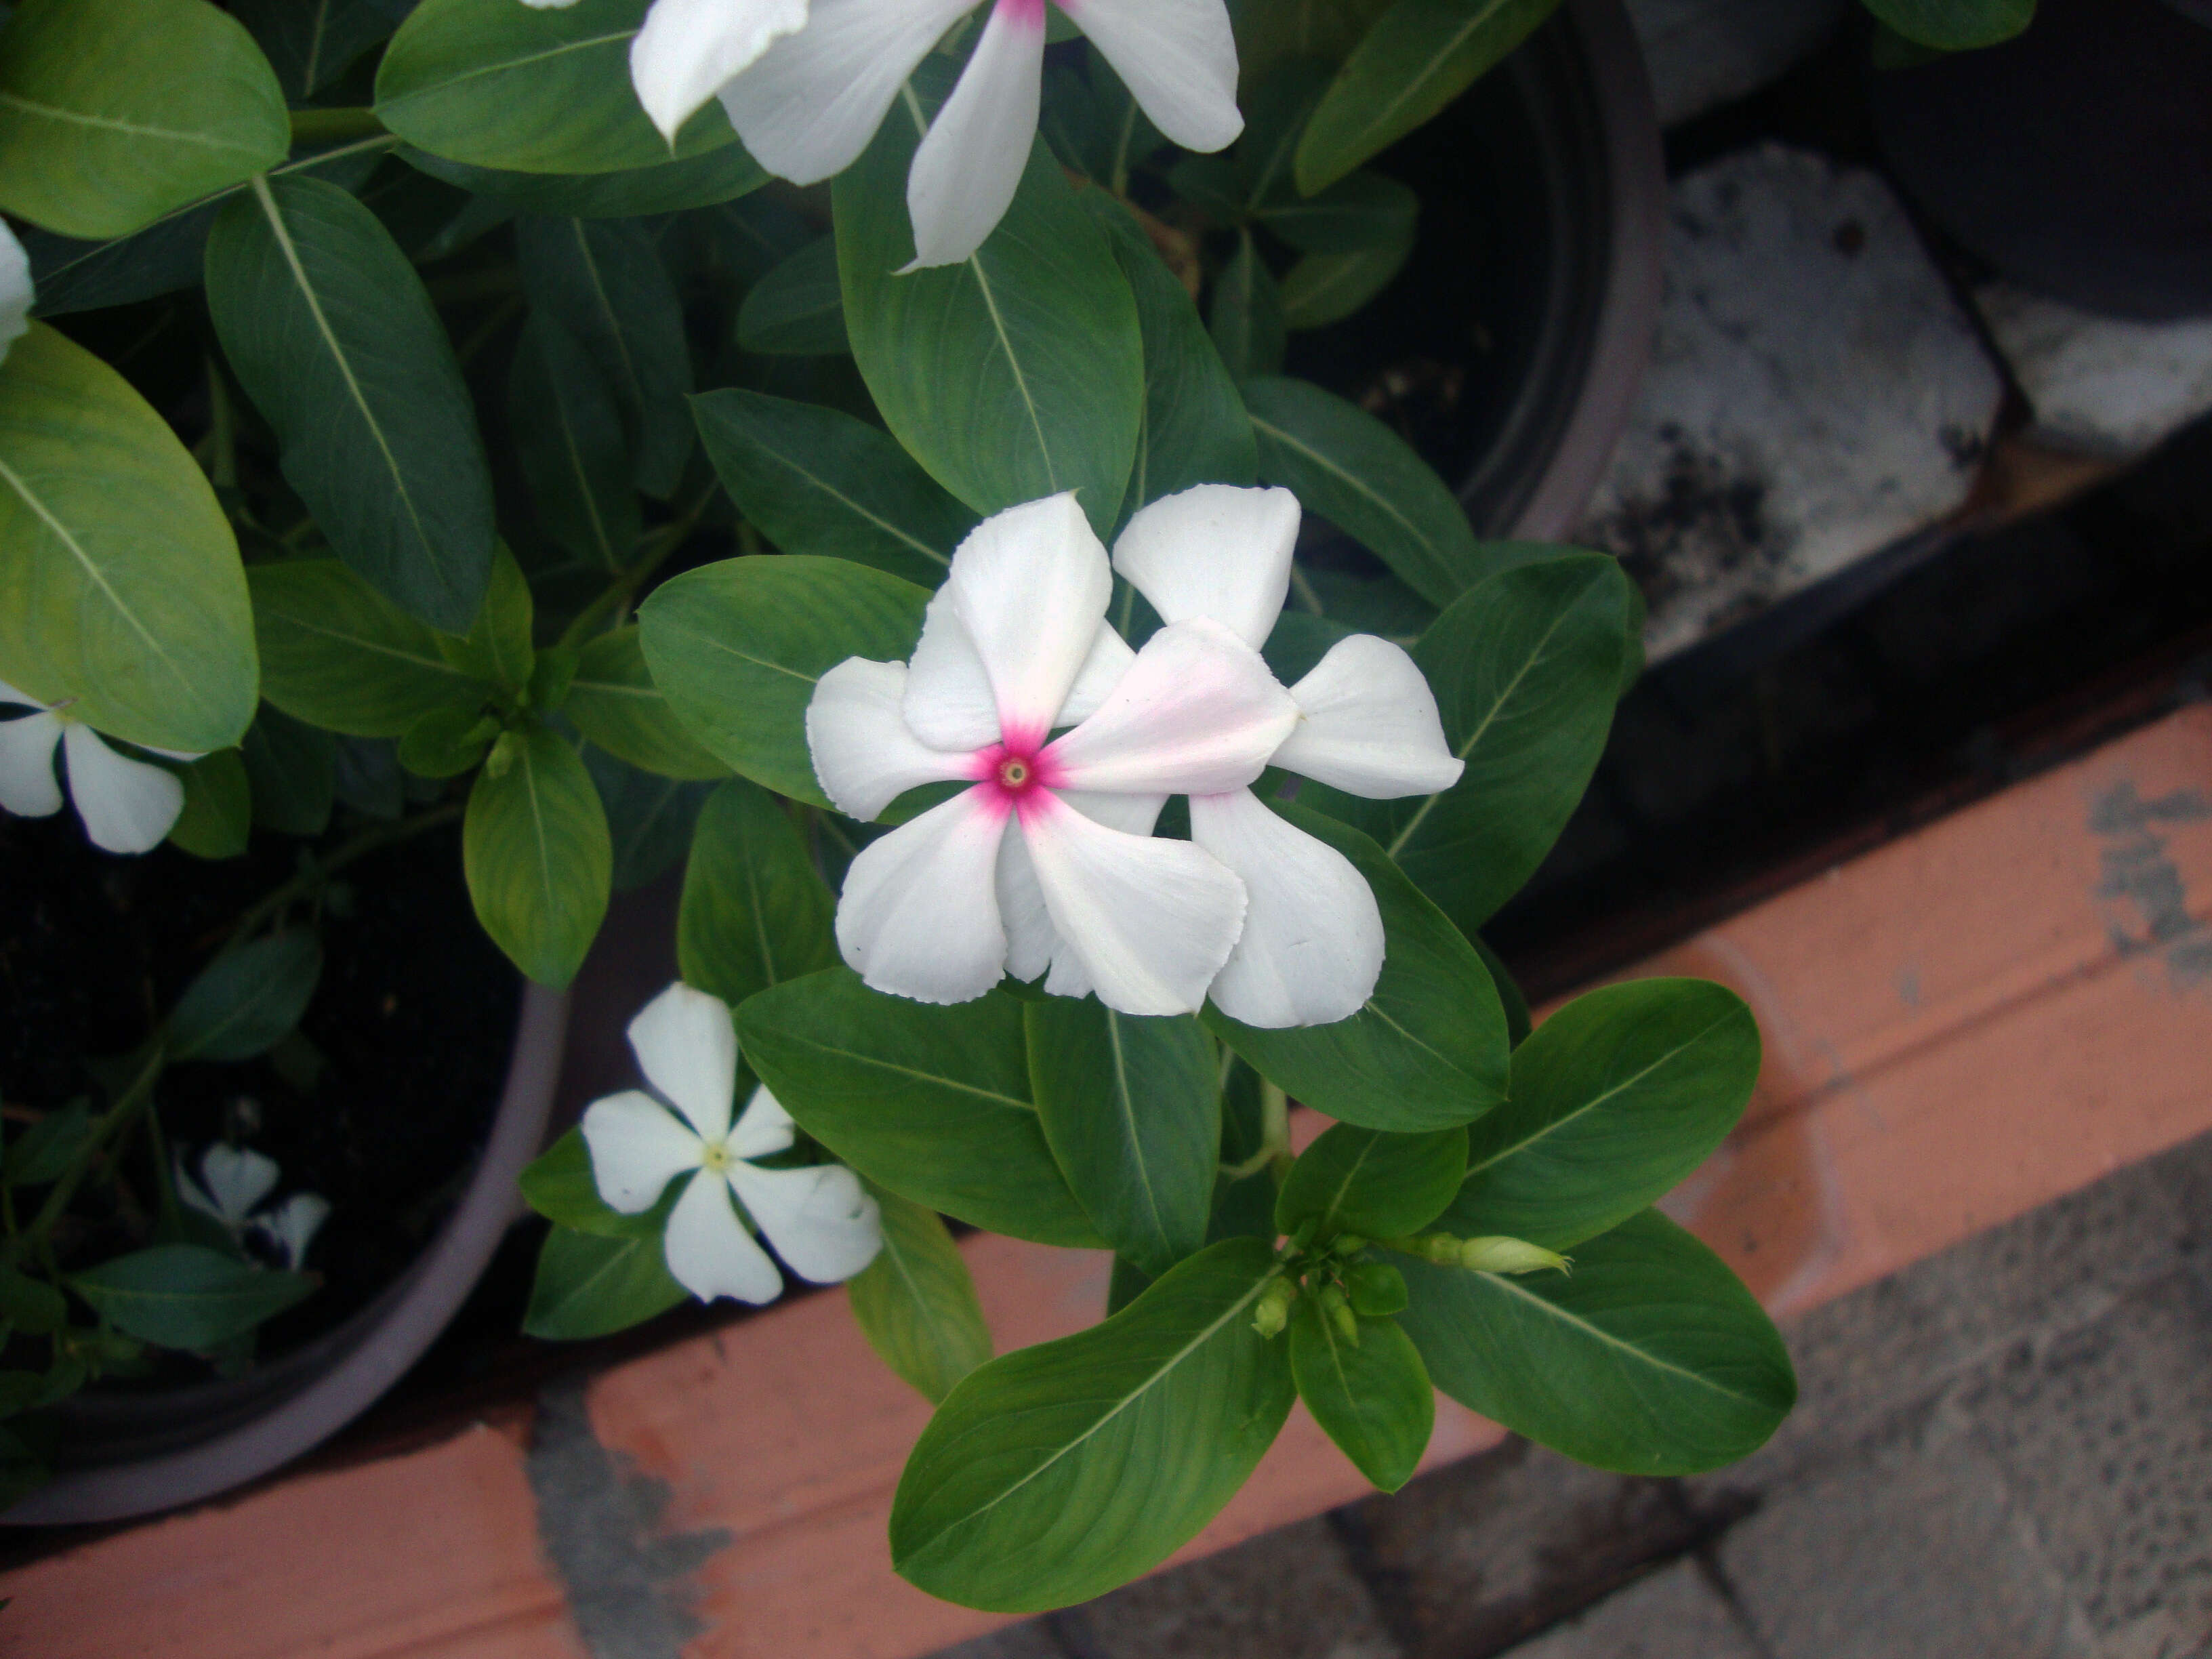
left=737, top=969, right=1099, bottom=1250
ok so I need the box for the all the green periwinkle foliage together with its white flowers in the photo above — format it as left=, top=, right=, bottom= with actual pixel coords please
left=0, top=0, right=2026, bottom=1610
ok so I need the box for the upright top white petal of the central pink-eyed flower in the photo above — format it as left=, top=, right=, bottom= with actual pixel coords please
left=937, top=493, right=1113, bottom=743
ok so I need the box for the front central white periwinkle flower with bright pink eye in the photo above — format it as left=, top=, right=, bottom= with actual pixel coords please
left=807, top=495, right=1298, bottom=1013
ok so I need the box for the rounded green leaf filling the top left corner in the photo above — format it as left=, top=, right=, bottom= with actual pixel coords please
left=0, top=0, right=292, bottom=237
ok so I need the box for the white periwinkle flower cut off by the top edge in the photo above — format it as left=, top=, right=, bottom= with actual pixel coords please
left=628, top=0, right=1243, bottom=266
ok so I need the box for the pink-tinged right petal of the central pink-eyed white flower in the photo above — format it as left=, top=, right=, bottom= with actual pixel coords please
left=1046, top=617, right=1298, bottom=794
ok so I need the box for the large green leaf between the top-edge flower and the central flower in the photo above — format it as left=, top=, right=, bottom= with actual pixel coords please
left=834, top=91, right=1143, bottom=535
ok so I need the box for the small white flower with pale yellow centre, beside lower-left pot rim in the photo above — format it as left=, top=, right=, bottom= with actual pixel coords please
left=584, top=982, right=882, bottom=1303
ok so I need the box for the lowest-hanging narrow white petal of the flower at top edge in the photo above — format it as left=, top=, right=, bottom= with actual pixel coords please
left=907, top=0, right=1044, bottom=270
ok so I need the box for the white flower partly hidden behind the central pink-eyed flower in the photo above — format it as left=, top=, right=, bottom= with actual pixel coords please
left=1113, top=485, right=1467, bottom=1026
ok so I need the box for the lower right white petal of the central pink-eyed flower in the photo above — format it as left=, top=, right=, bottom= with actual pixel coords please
left=1022, top=794, right=1246, bottom=1013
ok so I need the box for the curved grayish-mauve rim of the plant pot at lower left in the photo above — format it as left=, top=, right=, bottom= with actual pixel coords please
left=0, top=982, right=569, bottom=1526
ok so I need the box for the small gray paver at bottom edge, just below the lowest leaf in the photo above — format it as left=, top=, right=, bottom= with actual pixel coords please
left=1053, top=1519, right=1400, bottom=1659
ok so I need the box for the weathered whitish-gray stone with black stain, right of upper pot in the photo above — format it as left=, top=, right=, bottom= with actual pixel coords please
left=1577, top=144, right=2002, bottom=659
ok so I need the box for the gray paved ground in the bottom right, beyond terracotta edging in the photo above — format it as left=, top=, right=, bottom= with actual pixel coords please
left=938, top=1132, right=2212, bottom=1659
